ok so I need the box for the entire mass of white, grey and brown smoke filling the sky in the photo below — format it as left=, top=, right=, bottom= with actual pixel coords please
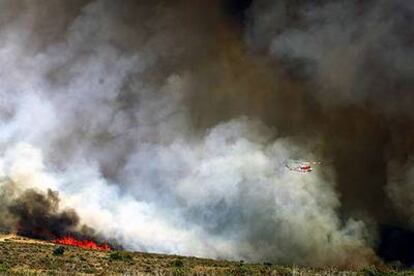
left=0, top=0, right=413, bottom=266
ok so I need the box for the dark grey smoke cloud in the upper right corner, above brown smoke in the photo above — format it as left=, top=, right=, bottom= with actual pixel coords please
left=252, top=0, right=414, bottom=111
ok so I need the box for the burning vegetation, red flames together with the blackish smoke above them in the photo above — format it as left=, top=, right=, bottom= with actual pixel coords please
left=2, top=184, right=111, bottom=251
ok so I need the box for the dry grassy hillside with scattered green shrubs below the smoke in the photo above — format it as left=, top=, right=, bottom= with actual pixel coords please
left=0, top=235, right=414, bottom=275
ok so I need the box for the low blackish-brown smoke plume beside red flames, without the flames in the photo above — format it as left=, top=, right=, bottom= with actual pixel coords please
left=0, top=179, right=103, bottom=243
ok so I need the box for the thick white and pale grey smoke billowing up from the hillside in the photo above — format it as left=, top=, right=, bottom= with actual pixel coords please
left=0, top=1, right=372, bottom=265
